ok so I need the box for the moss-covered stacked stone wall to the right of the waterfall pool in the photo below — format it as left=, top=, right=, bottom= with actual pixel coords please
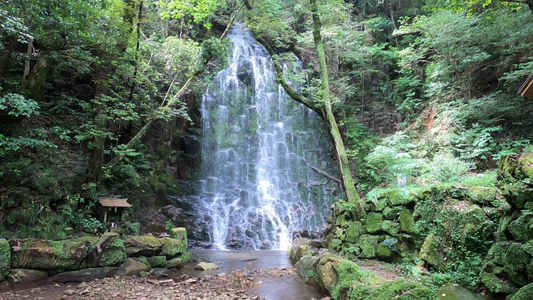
left=312, top=153, right=533, bottom=299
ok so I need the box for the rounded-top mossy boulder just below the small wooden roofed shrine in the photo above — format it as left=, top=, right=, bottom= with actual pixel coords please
left=87, top=232, right=127, bottom=267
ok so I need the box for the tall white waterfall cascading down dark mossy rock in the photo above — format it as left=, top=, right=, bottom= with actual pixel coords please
left=185, top=24, right=341, bottom=249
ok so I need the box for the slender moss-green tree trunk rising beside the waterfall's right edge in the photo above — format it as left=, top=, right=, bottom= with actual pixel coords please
left=310, top=0, right=365, bottom=218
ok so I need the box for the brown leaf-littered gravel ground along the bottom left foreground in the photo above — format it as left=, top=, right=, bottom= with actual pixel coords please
left=0, top=268, right=324, bottom=300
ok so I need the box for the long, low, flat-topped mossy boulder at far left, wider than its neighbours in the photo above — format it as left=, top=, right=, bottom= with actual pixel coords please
left=9, top=239, right=91, bottom=270
